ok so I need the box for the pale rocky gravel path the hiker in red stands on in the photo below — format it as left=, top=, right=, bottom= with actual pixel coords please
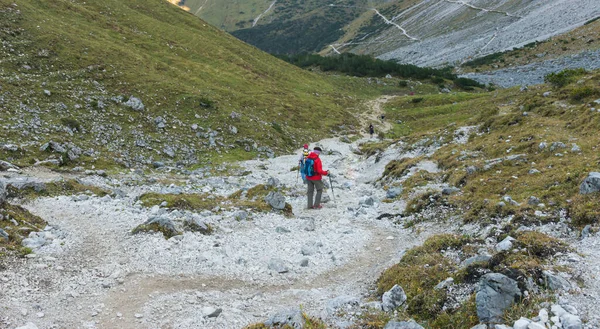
left=0, top=128, right=443, bottom=328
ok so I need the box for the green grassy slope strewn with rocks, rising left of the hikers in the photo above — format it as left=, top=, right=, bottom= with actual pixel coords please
left=0, top=0, right=390, bottom=167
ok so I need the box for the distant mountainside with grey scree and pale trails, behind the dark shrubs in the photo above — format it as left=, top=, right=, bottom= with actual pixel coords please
left=181, top=0, right=600, bottom=66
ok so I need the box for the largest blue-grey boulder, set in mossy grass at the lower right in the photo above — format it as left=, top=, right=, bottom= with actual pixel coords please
left=475, top=273, right=521, bottom=323
